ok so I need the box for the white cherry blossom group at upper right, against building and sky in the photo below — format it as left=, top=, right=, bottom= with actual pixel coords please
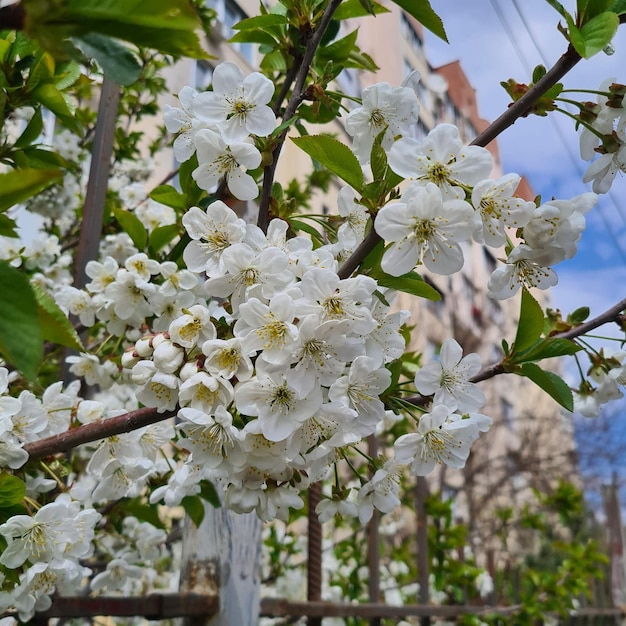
left=347, top=89, right=597, bottom=299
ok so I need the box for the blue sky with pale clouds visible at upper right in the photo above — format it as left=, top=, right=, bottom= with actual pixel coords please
left=426, top=0, right=626, bottom=314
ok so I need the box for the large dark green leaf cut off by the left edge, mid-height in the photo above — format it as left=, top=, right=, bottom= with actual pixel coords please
left=0, top=261, right=43, bottom=380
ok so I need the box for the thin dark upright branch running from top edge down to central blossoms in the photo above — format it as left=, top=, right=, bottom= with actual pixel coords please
left=257, top=0, right=342, bottom=232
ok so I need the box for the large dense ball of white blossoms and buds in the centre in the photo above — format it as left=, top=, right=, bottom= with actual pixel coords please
left=121, top=201, right=407, bottom=519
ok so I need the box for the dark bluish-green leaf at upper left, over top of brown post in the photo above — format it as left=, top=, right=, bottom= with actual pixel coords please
left=73, top=33, right=141, bottom=85
